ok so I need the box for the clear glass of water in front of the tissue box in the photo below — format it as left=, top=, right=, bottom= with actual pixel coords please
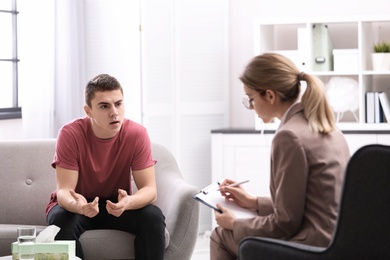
left=18, top=227, right=36, bottom=260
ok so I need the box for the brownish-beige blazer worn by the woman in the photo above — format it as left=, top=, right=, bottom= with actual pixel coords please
left=233, top=103, right=350, bottom=246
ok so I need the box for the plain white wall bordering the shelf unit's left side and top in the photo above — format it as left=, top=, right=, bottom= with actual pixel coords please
left=230, top=0, right=390, bottom=128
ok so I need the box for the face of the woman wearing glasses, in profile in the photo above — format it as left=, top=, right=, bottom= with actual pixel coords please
left=244, top=85, right=276, bottom=123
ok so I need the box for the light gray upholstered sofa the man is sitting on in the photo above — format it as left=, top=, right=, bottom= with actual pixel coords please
left=0, top=139, right=199, bottom=260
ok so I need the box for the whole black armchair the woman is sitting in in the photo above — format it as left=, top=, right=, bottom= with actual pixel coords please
left=239, top=145, right=390, bottom=260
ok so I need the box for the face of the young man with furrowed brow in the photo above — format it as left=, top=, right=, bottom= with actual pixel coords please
left=84, top=89, right=125, bottom=139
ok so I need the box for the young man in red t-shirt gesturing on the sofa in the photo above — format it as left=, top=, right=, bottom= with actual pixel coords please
left=46, top=74, right=165, bottom=260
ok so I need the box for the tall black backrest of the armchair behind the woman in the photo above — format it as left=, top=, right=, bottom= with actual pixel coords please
left=328, top=144, right=390, bottom=259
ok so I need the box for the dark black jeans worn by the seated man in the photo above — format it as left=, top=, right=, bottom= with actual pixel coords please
left=47, top=199, right=165, bottom=260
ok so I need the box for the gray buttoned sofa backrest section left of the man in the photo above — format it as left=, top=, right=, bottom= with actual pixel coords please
left=0, top=139, right=56, bottom=225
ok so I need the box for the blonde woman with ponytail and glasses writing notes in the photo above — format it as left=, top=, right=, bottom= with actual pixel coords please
left=210, top=53, right=350, bottom=260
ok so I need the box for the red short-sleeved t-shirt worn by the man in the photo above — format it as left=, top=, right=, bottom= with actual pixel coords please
left=46, top=117, right=155, bottom=214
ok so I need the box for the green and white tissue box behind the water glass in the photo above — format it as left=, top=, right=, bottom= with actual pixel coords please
left=11, top=240, right=76, bottom=260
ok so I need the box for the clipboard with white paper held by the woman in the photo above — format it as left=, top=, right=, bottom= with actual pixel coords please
left=193, top=181, right=258, bottom=218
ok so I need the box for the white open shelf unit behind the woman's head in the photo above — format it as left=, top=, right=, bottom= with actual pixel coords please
left=254, top=16, right=390, bottom=130
